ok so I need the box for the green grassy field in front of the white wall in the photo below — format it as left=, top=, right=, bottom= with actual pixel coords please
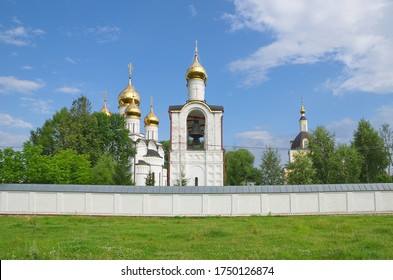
left=0, top=215, right=393, bottom=260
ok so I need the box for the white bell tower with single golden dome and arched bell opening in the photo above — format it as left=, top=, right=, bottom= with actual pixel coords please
left=168, top=41, right=224, bottom=186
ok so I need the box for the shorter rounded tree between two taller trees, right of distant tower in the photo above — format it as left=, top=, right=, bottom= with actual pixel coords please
left=329, top=145, right=363, bottom=184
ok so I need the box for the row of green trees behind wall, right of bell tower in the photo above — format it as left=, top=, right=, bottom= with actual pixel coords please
left=225, top=119, right=393, bottom=185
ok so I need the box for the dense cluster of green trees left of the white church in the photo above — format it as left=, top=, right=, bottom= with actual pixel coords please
left=0, top=96, right=135, bottom=185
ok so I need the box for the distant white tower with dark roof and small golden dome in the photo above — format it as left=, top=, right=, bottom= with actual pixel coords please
left=289, top=100, right=308, bottom=162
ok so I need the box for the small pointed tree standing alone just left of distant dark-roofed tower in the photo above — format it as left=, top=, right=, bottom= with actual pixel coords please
left=260, top=147, right=284, bottom=185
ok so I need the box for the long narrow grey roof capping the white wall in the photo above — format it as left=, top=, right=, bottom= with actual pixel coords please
left=0, top=183, right=393, bottom=194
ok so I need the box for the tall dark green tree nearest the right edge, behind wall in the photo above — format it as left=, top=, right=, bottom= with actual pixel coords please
left=352, top=119, right=389, bottom=183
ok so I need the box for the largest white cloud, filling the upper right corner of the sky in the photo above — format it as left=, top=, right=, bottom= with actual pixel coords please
left=225, top=0, right=393, bottom=94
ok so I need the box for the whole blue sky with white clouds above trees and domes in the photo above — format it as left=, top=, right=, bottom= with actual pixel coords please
left=0, top=0, right=393, bottom=162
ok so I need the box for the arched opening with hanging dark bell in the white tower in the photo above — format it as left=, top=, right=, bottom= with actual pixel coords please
left=187, top=110, right=205, bottom=150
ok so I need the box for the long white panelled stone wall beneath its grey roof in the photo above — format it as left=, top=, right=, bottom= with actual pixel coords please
left=0, top=188, right=393, bottom=216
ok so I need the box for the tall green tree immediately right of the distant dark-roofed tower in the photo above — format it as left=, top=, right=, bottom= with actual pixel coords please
left=308, top=126, right=335, bottom=184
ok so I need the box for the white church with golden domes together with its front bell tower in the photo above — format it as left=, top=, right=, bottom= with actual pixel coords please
left=101, top=43, right=225, bottom=186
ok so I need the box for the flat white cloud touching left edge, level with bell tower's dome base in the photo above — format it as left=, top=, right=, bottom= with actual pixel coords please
left=0, top=76, right=45, bottom=93
